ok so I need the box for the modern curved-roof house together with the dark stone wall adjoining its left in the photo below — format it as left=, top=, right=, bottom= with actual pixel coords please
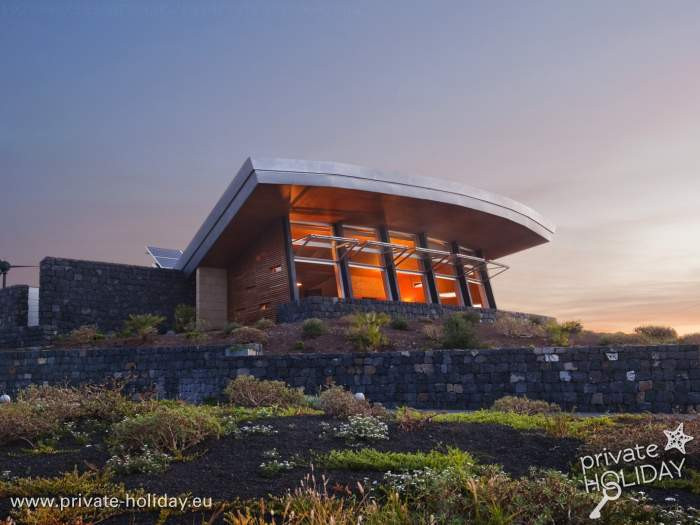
left=0, top=159, right=554, bottom=346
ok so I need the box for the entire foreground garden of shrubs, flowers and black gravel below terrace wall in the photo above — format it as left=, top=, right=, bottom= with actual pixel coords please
left=0, top=378, right=700, bottom=525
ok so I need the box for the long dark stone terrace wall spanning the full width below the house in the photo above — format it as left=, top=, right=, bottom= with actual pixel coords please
left=0, top=345, right=700, bottom=412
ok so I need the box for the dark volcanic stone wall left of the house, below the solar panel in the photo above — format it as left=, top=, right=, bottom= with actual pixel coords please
left=39, top=257, right=195, bottom=332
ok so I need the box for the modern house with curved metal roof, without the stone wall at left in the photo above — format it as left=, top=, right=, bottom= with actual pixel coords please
left=161, top=159, right=554, bottom=327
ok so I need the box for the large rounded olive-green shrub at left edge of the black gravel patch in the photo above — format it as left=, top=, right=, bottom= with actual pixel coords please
left=108, top=403, right=222, bottom=458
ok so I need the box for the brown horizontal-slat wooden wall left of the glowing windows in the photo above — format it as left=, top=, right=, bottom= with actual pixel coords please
left=228, top=221, right=290, bottom=323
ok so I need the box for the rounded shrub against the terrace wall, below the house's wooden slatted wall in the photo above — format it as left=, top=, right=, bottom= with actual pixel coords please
left=224, top=376, right=306, bottom=408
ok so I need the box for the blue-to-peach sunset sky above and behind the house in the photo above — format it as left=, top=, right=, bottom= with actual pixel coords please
left=0, top=0, right=700, bottom=333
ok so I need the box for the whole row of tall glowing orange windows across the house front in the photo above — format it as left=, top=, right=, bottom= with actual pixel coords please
left=290, top=216, right=489, bottom=308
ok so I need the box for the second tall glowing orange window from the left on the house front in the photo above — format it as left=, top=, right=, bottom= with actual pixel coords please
left=343, top=226, right=389, bottom=301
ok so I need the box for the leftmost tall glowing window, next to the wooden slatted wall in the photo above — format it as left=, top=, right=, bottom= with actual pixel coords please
left=290, top=222, right=343, bottom=297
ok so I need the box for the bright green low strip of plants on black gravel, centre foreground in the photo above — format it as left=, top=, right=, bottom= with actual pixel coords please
left=318, top=448, right=475, bottom=472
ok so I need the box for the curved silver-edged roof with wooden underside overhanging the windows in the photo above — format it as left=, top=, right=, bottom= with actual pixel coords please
left=176, top=158, right=554, bottom=274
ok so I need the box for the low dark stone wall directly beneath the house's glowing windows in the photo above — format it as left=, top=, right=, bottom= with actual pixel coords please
left=277, top=297, right=554, bottom=323
